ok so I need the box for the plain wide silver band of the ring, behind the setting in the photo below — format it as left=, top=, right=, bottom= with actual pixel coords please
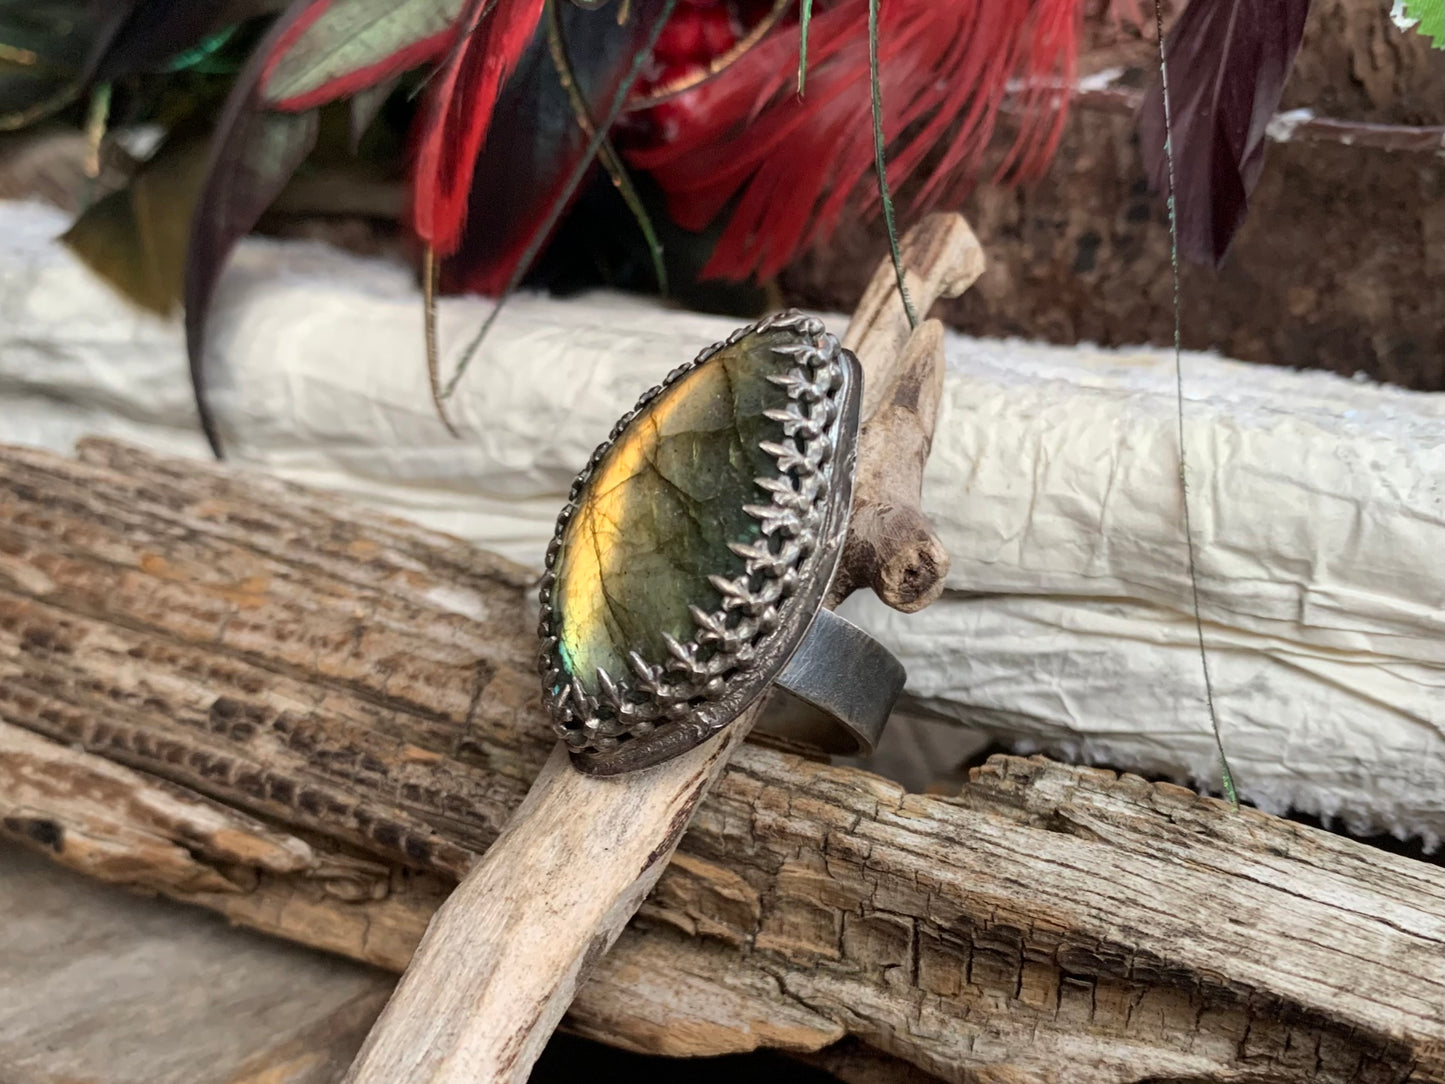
left=756, top=610, right=907, bottom=756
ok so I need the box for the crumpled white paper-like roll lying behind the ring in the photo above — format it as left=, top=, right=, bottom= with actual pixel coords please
left=0, top=204, right=1445, bottom=846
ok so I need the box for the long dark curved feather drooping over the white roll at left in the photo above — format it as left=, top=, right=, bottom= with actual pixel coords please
left=184, top=0, right=318, bottom=458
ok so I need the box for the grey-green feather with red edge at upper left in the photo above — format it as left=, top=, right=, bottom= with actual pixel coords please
left=260, top=0, right=465, bottom=106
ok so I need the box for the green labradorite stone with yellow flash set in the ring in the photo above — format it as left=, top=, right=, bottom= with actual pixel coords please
left=552, top=331, right=795, bottom=692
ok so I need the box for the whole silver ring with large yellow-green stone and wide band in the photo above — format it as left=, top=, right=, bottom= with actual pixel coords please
left=538, top=311, right=905, bottom=775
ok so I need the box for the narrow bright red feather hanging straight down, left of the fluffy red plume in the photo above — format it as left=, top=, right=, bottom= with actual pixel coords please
left=412, top=0, right=543, bottom=256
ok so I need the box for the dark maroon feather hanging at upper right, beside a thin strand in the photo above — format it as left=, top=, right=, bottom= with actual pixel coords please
left=1139, top=0, right=1309, bottom=264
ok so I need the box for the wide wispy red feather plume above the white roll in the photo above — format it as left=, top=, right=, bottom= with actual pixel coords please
left=629, top=0, right=1082, bottom=279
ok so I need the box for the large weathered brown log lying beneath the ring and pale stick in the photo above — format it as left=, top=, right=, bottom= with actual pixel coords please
left=0, top=444, right=1445, bottom=1083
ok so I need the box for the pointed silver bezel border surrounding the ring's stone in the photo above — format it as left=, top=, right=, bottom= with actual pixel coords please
left=538, top=311, right=863, bottom=775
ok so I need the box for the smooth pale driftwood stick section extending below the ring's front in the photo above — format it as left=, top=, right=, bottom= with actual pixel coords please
left=336, top=740, right=753, bottom=1084
